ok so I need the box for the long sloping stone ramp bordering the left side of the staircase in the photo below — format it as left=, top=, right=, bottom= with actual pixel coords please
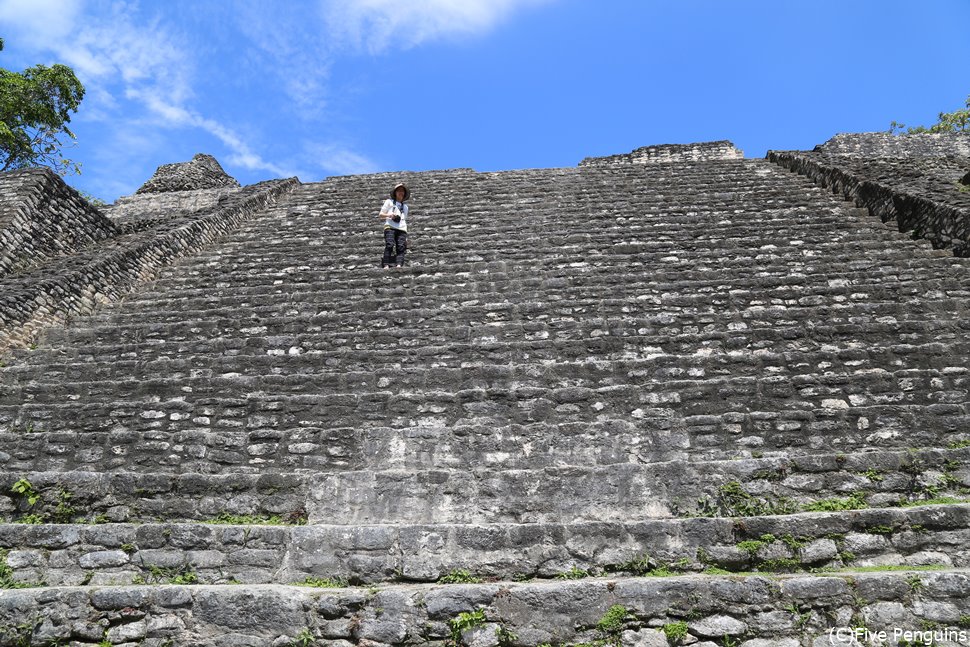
left=0, top=179, right=299, bottom=351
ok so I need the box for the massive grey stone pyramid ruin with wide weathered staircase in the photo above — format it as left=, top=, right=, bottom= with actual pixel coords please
left=0, top=134, right=970, bottom=647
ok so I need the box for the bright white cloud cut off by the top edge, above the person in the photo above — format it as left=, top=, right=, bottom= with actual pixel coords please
left=324, top=0, right=552, bottom=53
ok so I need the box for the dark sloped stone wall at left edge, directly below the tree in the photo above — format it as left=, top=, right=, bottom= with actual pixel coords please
left=0, top=168, right=120, bottom=278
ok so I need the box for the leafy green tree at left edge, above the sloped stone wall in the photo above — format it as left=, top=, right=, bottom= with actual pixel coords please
left=0, top=38, right=84, bottom=175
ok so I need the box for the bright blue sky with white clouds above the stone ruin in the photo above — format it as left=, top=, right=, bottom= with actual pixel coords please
left=0, top=0, right=970, bottom=202
